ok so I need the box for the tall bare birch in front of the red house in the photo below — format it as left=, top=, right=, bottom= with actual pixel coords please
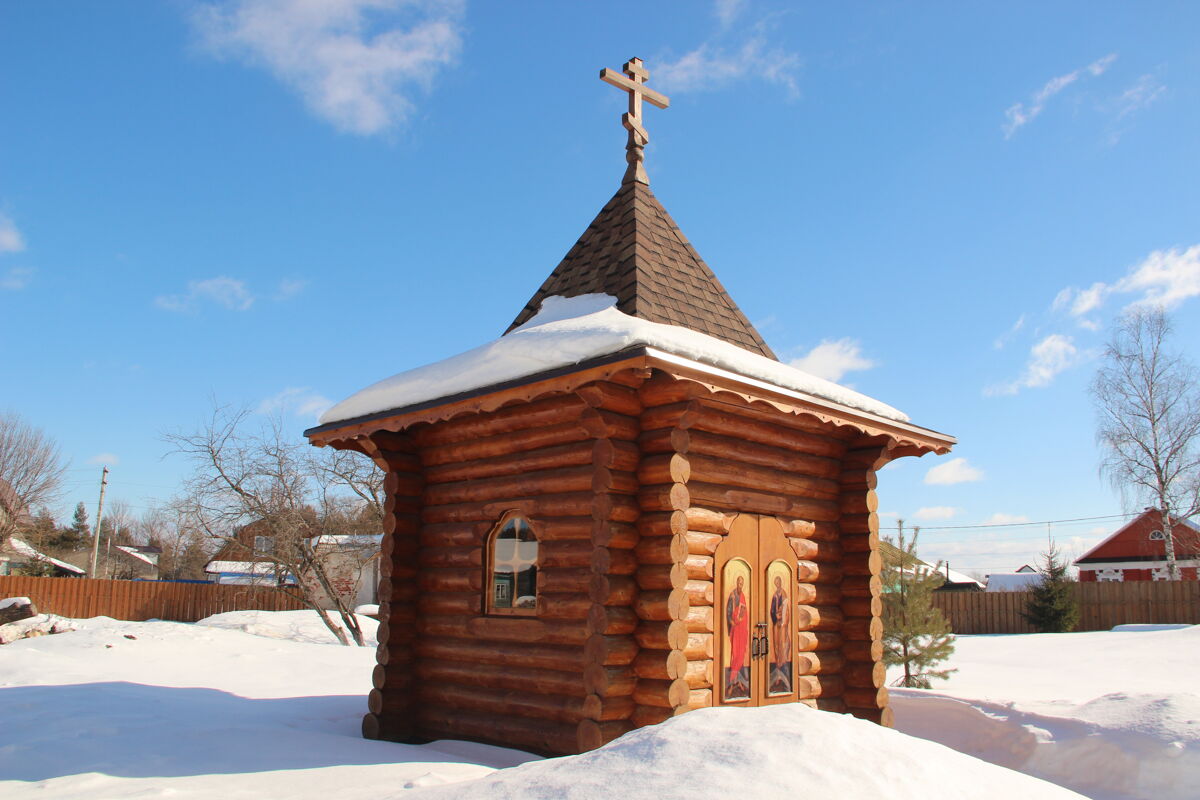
left=1092, top=308, right=1200, bottom=581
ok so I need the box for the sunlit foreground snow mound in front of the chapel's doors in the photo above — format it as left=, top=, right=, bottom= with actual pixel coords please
left=413, top=704, right=1080, bottom=800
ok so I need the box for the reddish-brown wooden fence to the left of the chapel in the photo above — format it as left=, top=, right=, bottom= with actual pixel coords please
left=0, top=576, right=304, bottom=622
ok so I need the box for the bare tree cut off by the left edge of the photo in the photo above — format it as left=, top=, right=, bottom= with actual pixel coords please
left=0, top=411, right=67, bottom=541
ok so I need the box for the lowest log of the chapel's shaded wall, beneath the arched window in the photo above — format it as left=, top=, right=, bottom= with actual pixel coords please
left=415, top=704, right=580, bottom=756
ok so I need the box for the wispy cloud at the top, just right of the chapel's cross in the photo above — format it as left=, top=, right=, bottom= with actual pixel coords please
left=654, top=0, right=802, bottom=97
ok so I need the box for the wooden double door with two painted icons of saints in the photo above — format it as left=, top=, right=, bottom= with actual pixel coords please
left=713, top=513, right=796, bottom=705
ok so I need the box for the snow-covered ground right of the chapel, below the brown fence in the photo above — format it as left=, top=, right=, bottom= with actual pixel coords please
left=892, top=625, right=1200, bottom=800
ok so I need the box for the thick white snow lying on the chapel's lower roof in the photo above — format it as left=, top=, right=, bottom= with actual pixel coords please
left=320, top=294, right=908, bottom=425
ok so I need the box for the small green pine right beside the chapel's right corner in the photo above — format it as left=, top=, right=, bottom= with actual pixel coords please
left=882, top=521, right=956, bottom=688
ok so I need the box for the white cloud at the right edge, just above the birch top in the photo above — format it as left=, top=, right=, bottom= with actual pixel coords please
left=1051, top=245, right=1200, bottom=330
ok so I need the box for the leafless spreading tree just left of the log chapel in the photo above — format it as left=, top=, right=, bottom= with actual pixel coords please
left=164, top=407, right=383, bottom=645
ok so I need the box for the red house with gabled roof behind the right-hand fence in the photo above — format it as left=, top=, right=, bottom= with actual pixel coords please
left=1075, top=509, right=1200, bottom=582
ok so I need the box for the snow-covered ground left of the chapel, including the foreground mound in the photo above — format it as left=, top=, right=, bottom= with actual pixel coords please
left=0, top=612, right=1079, bottom=800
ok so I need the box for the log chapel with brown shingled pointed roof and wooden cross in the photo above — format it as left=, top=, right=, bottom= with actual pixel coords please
left=306, top=59, right=954, bottom=754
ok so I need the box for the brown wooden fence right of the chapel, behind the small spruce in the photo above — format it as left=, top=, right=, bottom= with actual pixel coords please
left=934, top=581, right=1200, bottom=633
